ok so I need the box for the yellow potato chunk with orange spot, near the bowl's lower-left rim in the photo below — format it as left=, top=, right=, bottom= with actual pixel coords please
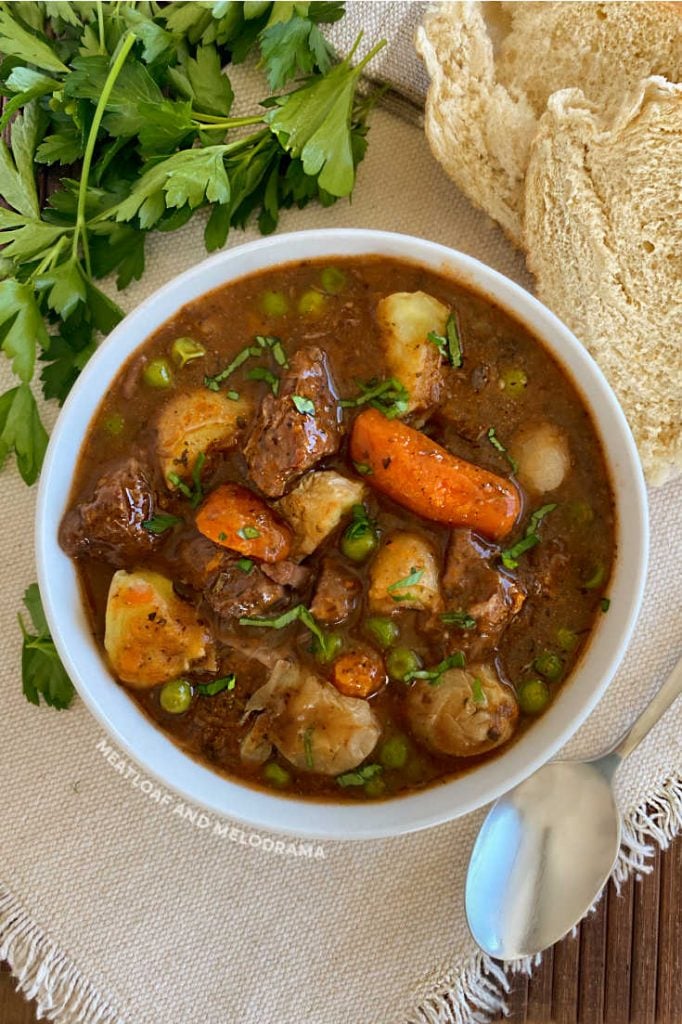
left=104, top=569, right=210, bottom=689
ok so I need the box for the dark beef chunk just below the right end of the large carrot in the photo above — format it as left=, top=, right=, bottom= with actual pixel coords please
left=442, top=529, right=525, bottom=658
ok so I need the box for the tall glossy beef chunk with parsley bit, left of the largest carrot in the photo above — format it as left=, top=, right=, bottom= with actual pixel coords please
left=244, top=346, right=341, bottom=498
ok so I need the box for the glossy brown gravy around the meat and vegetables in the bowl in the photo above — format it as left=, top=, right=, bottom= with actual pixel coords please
left=65, top=256, right=614, bottom=801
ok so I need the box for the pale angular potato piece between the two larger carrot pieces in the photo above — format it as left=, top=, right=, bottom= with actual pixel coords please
left=275, top=469, right=366, bottom=558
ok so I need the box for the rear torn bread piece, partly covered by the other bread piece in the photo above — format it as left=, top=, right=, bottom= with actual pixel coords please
left=417, top=0, right=682, bottom=245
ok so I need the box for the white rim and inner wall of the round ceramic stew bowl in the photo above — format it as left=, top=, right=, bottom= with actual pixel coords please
left=37, top=229, right=648, bottom=840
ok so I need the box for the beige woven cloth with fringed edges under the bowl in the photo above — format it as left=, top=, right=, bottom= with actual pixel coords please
left=0, top=4, right=682, bottom=1024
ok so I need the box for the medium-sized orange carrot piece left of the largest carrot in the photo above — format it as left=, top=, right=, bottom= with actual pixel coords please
left=196, top=483, right=293, bottom=562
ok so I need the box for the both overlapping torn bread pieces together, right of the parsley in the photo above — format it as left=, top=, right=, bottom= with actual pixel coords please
left=417, top=2, right=682, bottom=484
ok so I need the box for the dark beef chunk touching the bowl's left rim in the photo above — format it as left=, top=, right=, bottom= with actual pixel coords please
left=59, top=458, right=161, bottom=567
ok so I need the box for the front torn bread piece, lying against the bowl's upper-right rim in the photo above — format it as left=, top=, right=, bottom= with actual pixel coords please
left=524, top=78, right=682, bottom=484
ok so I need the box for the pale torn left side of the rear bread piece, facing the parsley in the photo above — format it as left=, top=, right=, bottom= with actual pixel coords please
left=416, top=3, right=537, bottom=245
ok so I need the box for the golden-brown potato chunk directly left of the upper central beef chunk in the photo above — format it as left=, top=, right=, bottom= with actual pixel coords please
left=157, top=388, right=251, bottom=486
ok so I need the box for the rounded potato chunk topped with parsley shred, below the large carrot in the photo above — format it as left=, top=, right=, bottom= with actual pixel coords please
left=370, top=530, right=442, bottom=612
